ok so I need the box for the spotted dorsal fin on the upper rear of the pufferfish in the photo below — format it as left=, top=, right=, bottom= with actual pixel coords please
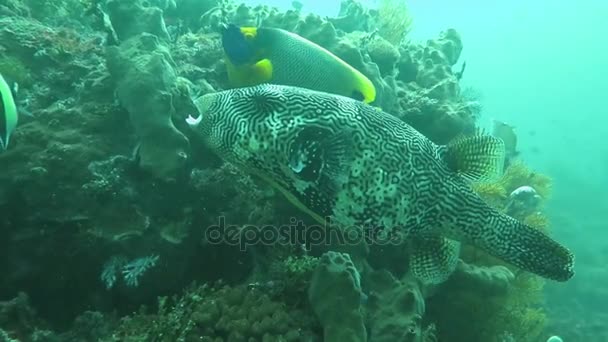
left=443, top=131, right=506, bottom=182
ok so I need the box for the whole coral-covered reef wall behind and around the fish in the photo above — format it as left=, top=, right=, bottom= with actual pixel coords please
left=0, top=0, right=592, bottom=342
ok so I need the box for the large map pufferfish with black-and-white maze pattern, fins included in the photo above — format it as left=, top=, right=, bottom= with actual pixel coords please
left=186, top=84, right=574, bottom=283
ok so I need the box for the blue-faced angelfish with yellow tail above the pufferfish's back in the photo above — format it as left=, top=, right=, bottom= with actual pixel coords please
left=222, top=25, right=376, bottom=103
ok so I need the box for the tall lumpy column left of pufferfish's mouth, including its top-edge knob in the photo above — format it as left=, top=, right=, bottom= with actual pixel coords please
left=107, top=0, right=189, bottom=179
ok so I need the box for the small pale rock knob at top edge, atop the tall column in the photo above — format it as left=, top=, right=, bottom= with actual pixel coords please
left=107, top=0, right=169, bottom=41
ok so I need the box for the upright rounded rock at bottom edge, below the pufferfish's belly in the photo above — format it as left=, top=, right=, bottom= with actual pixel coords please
left=308, top=251, right=367, bottom=342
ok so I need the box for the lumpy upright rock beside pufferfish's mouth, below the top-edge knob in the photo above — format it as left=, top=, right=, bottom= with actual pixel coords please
left=107, top=33, right=189, bottom=180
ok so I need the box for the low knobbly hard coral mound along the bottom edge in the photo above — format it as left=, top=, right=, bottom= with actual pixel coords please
left=115, top=283, right=316, bottom=341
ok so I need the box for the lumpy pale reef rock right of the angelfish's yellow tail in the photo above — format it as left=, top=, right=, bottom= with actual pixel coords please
left=388, top=29, right=479, bottom=144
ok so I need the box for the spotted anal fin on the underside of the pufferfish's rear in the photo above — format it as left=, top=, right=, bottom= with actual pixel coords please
left=409, top=235, right=460, bottom=284
